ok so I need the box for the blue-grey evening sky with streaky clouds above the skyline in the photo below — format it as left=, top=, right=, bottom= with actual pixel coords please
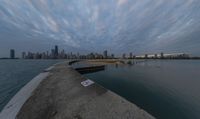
left=0, top=0, right=200, bottom=57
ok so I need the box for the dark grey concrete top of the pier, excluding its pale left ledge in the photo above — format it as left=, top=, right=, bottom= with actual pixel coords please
left=4, top=62, right=154, bottom=119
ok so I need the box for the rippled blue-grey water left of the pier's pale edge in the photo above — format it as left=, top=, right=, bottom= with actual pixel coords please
left=0, top=60, right=60, bottom=111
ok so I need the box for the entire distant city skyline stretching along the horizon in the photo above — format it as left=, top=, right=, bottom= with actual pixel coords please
left=0, top=45, right=195, bottom=59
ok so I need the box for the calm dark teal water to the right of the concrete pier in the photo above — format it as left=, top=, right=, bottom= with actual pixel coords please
left=85, top=60, right=200, bottom=119
